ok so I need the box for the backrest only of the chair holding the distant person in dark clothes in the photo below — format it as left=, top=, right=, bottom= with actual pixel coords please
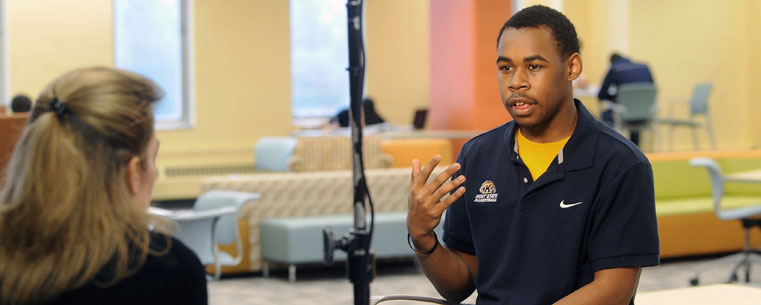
left=616, top=83, right=657, bottom=122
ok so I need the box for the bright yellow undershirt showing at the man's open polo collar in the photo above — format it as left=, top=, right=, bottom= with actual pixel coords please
left=515, top=129, right=571, bottom=181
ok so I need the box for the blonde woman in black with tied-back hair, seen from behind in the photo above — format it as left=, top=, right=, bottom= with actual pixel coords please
left=0, top=68, right=207, bottom=304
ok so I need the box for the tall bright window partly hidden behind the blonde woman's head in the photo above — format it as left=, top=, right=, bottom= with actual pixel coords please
left=114, top=0, right=191, bottom=129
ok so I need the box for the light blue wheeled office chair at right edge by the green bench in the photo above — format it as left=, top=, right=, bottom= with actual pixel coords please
left=690, top=158, right=761, bottom=286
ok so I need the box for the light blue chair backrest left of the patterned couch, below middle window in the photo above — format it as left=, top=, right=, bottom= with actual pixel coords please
left=254, top=137, right=297, bottom=172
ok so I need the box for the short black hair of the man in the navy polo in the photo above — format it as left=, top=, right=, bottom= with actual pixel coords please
left=497, top=5, right=579, bottom=58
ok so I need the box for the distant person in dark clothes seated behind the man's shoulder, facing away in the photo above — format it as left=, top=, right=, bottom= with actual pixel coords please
left=597, top=53, right=653, bottom=145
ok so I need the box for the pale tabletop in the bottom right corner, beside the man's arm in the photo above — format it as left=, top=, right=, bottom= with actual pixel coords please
left=635, top=284, right=761, bottom=305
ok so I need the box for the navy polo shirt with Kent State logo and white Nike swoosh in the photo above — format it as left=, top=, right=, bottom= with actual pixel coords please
left=443, top=100, right=659, bottom=304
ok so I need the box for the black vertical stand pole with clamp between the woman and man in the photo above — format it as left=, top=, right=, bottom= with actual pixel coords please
left=323, top=0, right=375, bottom=305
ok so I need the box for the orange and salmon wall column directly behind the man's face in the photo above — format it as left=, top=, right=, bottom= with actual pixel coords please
left=429, top=0, right=511, bottom=156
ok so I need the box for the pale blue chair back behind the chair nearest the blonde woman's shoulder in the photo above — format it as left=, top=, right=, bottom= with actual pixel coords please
left=193, top=191, right=259, bottom=244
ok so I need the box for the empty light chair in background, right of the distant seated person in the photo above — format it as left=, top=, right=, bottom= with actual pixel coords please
left=658, top=83, right=716, bottom=150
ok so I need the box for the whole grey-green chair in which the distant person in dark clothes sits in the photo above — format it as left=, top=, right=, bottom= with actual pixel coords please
left=612, top=83, right=657, bottom=147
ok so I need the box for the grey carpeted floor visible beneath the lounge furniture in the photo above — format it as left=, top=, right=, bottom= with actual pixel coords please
left=209, top=254, right=761, bottom=305
